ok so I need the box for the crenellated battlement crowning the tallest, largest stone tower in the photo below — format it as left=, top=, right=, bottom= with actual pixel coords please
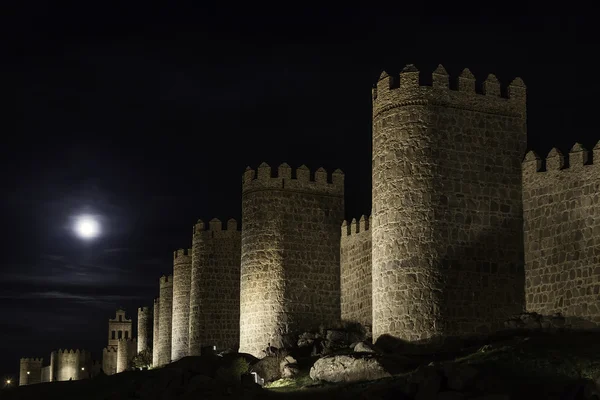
left=372, top=64, right=527, bottom=117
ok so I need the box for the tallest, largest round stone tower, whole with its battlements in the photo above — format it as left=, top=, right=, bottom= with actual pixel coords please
left=371, top=66, right=526, bottom=340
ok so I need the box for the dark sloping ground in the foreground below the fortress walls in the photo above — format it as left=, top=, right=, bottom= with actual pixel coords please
left=0, top=332, right=600, bottom=400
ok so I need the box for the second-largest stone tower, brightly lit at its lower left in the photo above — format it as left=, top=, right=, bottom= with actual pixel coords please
left=240, top=163, right=344, bottom=356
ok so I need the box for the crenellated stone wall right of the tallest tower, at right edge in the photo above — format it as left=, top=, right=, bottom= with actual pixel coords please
left=523, top=142, right=600, bottom=324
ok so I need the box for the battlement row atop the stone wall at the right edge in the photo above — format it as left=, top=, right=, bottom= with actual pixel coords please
left=522, top=141, right=600, bottom=174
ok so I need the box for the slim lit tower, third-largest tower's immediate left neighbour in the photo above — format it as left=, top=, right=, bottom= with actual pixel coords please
left=171, top=249, right=192, bottom=361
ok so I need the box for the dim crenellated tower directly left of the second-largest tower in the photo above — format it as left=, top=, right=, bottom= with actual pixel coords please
left=189, top=218, right=241, bottom=355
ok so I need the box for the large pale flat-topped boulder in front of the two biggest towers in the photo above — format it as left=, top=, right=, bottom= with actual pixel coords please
left=310, top=354, right=392, bottom=382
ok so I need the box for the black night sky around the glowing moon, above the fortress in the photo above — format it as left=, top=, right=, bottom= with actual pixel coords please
left=0, top=7, right=600, bottom=377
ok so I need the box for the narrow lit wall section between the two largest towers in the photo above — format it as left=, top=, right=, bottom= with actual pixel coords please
left=340, top=215, right=373, bottom=326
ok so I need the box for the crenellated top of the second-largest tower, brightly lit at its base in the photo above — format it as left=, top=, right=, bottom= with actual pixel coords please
left=242, top=162, right=344, bottom=196
